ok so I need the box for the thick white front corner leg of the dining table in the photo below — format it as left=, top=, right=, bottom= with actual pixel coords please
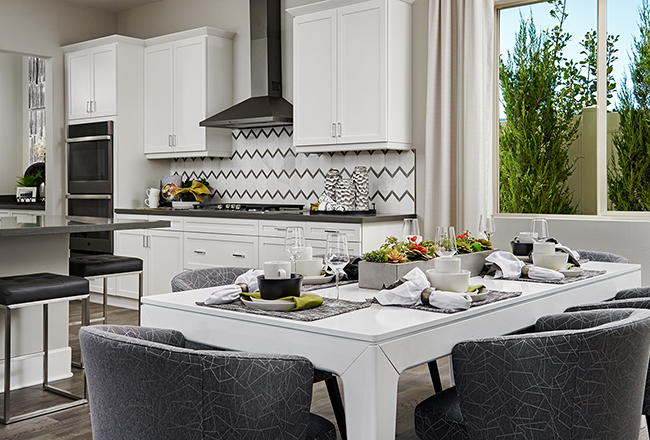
left=341, top=346, right=399, bottom=440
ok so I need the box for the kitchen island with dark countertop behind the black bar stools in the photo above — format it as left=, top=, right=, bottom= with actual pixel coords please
left=0, top=215, right=169, bottom=389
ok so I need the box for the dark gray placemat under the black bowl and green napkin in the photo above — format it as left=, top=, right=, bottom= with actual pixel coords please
left=196, top=296, right=372, bottom=321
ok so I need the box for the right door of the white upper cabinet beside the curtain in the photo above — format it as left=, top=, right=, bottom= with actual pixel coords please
left=337, top=1, right=387, bottom=144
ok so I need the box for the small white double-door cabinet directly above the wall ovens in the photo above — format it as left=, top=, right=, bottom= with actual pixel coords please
left=65, top=43, right=118, bottom=120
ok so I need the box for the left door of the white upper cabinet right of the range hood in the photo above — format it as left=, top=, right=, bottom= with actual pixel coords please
left=293, top=10, right=337, bottom=145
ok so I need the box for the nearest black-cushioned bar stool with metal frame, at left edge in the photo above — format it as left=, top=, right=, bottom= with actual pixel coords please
left=0, top=273, right=90, bottom=425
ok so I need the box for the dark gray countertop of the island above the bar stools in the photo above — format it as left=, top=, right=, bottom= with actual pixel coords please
left=0, top=215, right=170, bottom=237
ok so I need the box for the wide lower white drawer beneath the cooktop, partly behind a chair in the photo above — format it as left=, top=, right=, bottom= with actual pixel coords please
left=184, top=232, right=258, bottom=269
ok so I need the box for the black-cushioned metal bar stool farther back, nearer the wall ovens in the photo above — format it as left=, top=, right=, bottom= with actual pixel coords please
left=69, top=254, right=143, bottom=325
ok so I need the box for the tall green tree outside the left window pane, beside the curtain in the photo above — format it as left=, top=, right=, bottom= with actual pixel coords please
left=499, top=0, right=584, bottom=214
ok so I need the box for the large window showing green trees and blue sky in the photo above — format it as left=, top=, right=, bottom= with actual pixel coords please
left=498, top=0, right=650, bottom=214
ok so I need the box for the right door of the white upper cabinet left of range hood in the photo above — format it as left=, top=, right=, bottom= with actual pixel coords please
left=174, top=37, right=205, bottom=152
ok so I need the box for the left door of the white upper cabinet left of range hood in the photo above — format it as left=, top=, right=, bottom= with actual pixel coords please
left=144, top=43, right=174, bottom=153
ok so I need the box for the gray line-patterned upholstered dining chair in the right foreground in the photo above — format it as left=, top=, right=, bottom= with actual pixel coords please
left=415, top=309, right=650, bottom=440
